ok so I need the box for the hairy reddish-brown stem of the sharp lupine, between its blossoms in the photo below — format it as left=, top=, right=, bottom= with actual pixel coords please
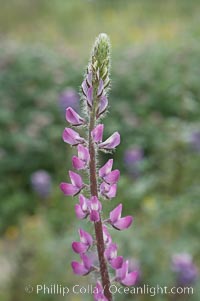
left=89, top=106, right=112, bottom=301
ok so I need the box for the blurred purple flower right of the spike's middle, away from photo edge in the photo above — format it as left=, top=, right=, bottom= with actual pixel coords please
left=124, top=147, right=144, bottom=177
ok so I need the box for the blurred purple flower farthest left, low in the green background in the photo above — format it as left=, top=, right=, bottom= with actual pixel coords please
left=31, top=170, right=51, bottom=198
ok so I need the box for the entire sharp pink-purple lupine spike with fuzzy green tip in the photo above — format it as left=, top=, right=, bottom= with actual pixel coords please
left=60, top=34, right=138, bottom=301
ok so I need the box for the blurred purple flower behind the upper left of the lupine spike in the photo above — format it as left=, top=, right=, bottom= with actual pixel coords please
left=58, top=88, right=79, bottom=114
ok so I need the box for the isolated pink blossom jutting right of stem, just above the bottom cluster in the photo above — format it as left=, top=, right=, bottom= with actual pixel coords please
left=108, top=204, right=133, bottom=230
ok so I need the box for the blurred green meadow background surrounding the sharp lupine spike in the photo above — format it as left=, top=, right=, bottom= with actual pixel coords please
left=0, top=0, right=200, bottom=301
